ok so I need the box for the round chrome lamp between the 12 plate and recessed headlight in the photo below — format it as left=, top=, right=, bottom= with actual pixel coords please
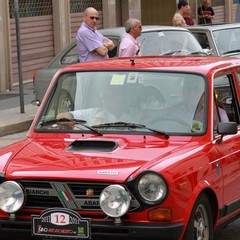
left=100, top=185, right=131, bottom=218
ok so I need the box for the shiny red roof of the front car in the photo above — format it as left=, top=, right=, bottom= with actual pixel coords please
left=61, top=56, right=240, bottom=74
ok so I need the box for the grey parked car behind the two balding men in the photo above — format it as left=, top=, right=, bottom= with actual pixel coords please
left=33, top=26, right=204, bottom=105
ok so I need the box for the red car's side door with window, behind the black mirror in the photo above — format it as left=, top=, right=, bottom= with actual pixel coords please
left=213, top=73, right=240, bottom=209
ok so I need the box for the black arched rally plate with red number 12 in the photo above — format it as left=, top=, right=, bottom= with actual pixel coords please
left=32, top=208, right=91, bottom=239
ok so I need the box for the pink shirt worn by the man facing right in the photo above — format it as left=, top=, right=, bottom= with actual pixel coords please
left=119, top=33, right=140, bottom=57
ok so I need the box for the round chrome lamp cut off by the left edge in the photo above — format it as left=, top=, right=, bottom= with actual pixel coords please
left=0, top=181, right=25, bottom=213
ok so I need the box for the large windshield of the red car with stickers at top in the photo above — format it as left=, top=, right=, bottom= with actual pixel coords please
left=35, top=71, right=207, bottom=135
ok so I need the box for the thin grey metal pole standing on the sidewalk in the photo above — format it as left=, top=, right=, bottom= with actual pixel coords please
left=14, top=0, right=25, bottom=113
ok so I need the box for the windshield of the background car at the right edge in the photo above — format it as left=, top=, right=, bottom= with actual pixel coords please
left=213, top=28, right=240, bottom=55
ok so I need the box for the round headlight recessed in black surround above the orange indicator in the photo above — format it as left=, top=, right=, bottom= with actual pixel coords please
left=138, top=172, right=167, bottom=204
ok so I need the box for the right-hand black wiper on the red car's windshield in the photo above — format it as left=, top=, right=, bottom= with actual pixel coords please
left=92, top=122, right=169, bottom=139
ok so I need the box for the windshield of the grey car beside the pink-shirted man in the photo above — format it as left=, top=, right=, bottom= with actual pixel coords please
left=137, top=30, right=203, bottom=56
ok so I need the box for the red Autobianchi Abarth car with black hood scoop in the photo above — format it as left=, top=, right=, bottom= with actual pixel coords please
left=0, top=56, right=240, bottom=240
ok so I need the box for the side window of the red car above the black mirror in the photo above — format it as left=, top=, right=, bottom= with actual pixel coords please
left=213, top=74, right=239, bottom=128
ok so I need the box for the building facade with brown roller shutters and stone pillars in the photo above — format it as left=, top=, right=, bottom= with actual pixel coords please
left=0, top=0, right=238, bottom=92
